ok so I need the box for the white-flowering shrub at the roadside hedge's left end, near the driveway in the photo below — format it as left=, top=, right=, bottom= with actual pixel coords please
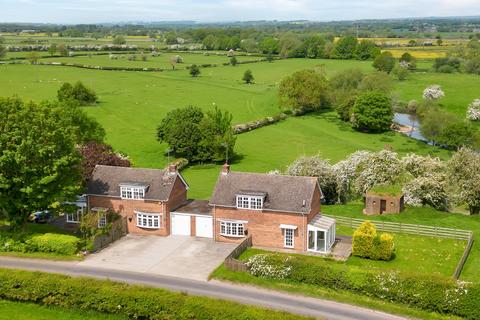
left=246, top=254, right=292, bottom=279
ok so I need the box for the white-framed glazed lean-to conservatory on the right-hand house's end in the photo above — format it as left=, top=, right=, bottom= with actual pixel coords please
left=307, top=214, right=335, bottom=253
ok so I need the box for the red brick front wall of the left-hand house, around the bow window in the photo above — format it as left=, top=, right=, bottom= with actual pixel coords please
left=88, top=196, right=170, bottom=236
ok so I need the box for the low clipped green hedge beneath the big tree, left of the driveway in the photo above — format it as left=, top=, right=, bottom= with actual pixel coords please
left=0, top=231, right=80, bottom=255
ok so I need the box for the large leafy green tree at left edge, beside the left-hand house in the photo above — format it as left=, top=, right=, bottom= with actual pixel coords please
left=0, top=98, right=81, bottom=227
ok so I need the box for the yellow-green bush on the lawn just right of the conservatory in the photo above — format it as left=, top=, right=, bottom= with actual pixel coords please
left=352, top=221, right=394, bottom=261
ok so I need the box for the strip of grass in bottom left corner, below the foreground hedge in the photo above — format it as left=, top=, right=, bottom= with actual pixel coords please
left=0, top=300, right=128, bottom=320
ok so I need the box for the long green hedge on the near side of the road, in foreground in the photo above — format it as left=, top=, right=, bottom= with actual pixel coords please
left=0, top=269, right=303, bottom=320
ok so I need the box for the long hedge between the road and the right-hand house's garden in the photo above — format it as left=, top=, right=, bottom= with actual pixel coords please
left=248, top=254, right=480, bottom=319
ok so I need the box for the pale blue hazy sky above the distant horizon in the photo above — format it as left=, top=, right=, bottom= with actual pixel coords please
left=0, top=0, right=480, bottom=24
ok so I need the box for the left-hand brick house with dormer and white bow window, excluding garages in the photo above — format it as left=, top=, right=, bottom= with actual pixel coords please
left=86, top=165, right=189, bottom=236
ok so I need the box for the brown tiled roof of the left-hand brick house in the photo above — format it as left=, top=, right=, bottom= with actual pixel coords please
left=87, top=165, right=188, bottom=201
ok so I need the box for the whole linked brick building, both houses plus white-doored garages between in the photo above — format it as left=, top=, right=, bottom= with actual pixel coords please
left=82, top=165, right=335, bottom=253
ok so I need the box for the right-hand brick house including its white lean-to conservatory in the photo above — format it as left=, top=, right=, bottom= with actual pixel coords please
left=210, top=164, right=335, bottom=253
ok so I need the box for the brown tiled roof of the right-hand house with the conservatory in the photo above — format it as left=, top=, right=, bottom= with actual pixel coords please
left=210, top=171, right=321, bottom=213
